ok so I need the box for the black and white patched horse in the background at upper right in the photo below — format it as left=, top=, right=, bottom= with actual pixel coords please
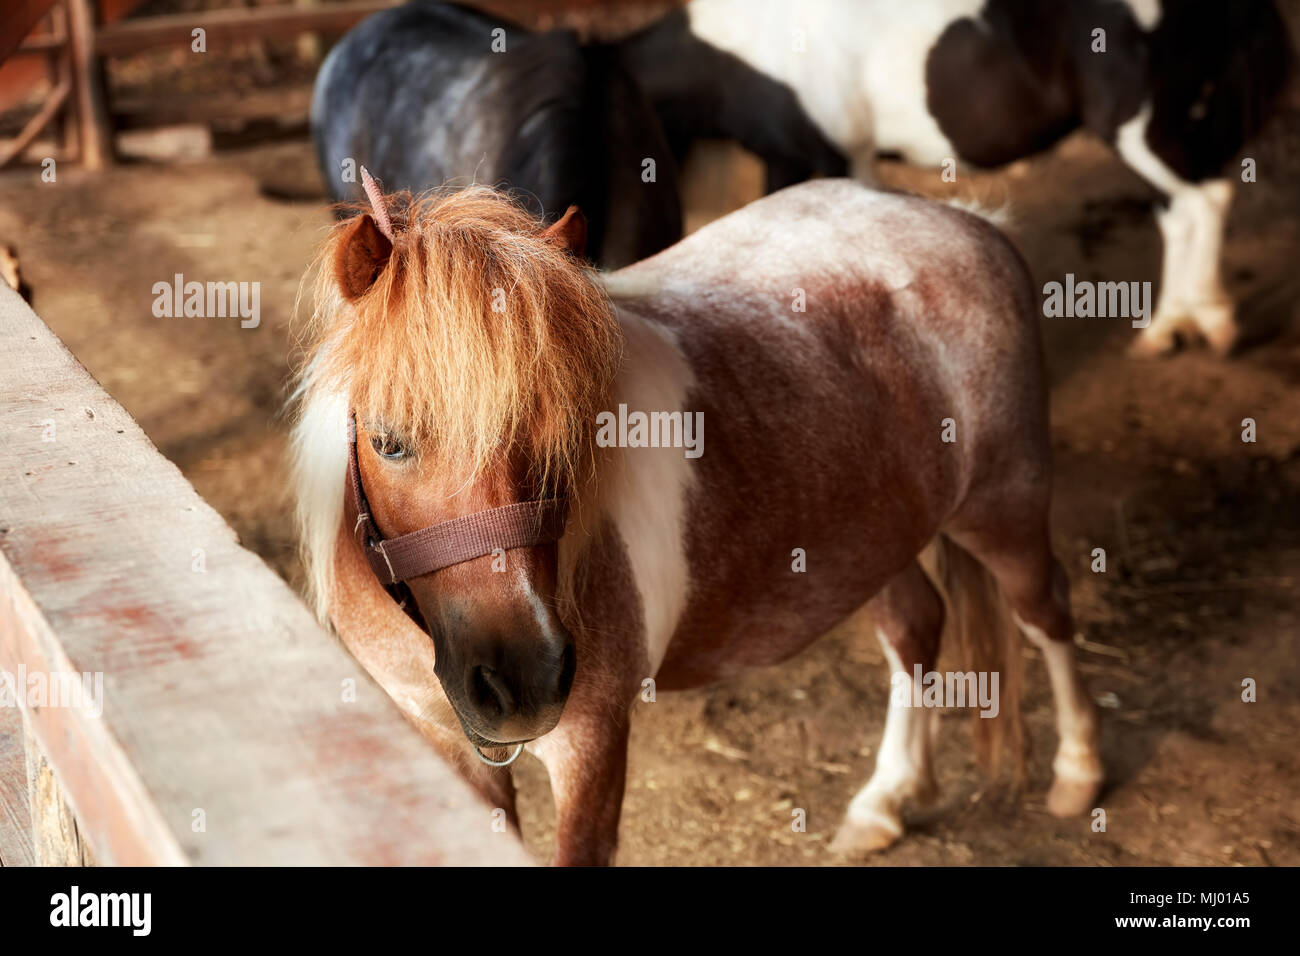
left=625, top=0, right=1291, bottom=354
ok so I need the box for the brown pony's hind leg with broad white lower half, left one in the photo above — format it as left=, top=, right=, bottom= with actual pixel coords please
left=831, top=563, right=944, bottom=855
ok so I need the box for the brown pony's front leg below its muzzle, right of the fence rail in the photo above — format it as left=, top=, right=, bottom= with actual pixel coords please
left=528, top=713, right=628, bottom=866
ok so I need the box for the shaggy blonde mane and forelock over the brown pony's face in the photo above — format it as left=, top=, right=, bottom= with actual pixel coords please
left=294, top=186, right=623, bottom=615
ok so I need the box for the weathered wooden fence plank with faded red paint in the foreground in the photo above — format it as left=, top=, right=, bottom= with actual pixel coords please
left=0, top=289, right=528, bottom=865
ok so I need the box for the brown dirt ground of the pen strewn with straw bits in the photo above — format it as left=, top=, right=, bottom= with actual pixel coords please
left=0, top=4, right=1300, bottom=865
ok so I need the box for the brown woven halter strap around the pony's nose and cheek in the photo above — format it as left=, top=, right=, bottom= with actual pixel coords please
left=347, top=415, right=568, bottom=588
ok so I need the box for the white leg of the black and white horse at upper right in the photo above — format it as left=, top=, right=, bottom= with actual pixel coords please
left=1115, top=107, right=1238, bottom=355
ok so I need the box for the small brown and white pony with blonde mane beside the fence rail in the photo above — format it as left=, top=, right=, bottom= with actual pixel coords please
left=294, top=179, right=1102, bottom=864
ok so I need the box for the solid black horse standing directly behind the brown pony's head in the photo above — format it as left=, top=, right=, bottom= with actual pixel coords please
left=312, top=0, right=681, bottom=268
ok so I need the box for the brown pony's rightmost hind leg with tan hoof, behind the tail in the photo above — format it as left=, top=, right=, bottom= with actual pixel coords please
left=952, top=520, right=1102, bottom=817
